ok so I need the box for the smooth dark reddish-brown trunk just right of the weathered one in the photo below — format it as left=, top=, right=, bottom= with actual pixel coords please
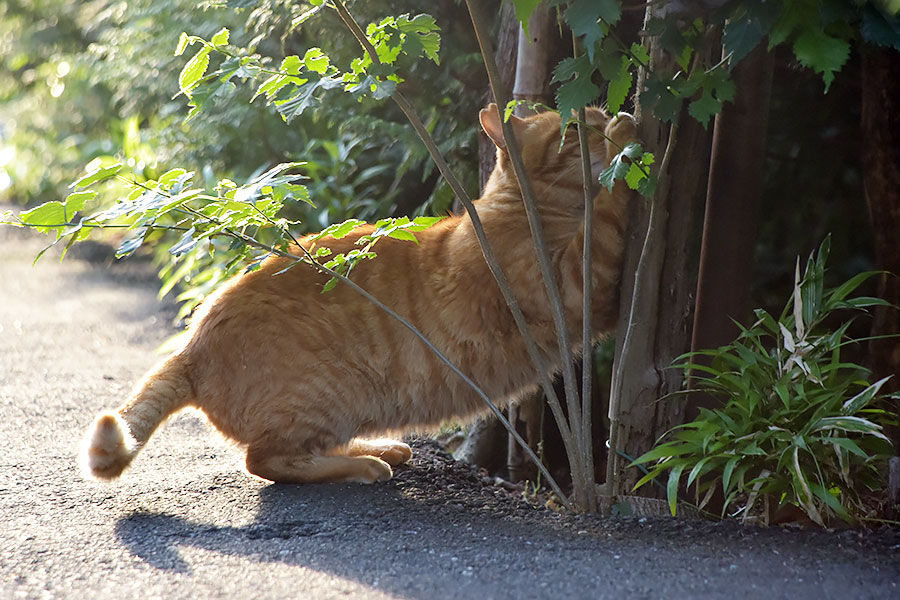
left=685, top=44, right=774, bottom=420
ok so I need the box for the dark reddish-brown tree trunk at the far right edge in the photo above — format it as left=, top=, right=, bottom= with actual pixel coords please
left=862, top=46, right=900, bottom=452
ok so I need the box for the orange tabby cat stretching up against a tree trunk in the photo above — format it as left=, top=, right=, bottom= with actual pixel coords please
left=82, top=105, right=634, bottom=483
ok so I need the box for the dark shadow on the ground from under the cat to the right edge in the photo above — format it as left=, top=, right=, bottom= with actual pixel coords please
left=116, top=440, right=900, bottom=599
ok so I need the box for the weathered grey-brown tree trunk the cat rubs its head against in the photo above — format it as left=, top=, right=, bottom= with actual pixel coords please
left=604, top=25, right=710, bottom=501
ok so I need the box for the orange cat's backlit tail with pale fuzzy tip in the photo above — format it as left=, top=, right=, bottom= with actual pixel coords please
left=79, top=354, right=194, bottom=480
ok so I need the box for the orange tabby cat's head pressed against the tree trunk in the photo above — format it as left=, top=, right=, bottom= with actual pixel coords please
left=479, top=103, right=635, bottom=197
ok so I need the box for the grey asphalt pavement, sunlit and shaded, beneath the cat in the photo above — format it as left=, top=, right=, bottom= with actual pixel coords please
left=0, top=227, right=900, bottom=600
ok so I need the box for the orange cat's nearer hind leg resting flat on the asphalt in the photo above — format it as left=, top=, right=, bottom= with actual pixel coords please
left=247, top=448, right=393, bottom=483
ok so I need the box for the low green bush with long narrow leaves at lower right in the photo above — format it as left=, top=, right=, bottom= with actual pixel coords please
left=632, top=239, right=894, bottom=526
